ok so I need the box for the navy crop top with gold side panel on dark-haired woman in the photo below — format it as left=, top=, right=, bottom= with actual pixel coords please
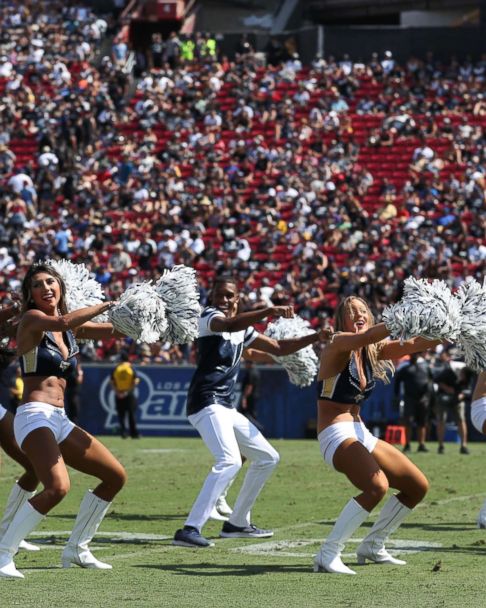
left=20, top=330, right=79, bottom=378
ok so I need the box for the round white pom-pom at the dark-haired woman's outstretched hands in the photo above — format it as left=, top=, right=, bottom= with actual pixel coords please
left=108, top=283, right=167, bottom=344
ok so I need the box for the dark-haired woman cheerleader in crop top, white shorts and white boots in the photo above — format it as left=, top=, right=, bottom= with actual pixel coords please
left=0, top=264, right=126, bottom=578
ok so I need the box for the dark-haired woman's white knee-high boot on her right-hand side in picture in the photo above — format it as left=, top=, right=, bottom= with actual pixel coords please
left=62, top=490, right=112, bottom=570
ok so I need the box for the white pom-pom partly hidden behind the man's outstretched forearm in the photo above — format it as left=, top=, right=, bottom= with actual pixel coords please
left=265, top=317, right=318, bottom=387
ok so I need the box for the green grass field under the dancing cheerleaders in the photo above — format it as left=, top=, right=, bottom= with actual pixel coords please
left=0, top=438, right=486, bottom=608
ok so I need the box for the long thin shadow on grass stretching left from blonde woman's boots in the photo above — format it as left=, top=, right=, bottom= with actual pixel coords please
left=133, top=560, right=312, bottom=576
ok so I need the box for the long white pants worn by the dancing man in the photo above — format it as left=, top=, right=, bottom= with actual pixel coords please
left=186, top=405, right=280, bottom=531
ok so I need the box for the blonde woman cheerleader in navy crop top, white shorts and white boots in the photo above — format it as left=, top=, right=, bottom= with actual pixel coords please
left=314, top=296, right=440, bottom=574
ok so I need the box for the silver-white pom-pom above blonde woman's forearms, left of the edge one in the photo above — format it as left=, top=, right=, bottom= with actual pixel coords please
left=382, top=277, right=461, bottom=340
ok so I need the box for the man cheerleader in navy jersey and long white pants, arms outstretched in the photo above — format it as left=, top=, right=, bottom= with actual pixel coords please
left=173, top=278, right=328, bottom=548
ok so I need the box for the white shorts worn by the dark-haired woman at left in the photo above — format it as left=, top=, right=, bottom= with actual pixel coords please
left=14, top=401, right=76, bottom=446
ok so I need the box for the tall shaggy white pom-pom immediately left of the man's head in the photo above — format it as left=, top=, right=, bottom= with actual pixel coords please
left=155, top=264, right=201, bottom=344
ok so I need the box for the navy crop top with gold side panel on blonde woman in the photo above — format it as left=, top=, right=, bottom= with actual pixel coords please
left=317, top=353, right=375, bottom=404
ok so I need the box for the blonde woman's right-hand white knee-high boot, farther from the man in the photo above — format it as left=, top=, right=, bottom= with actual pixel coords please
left=356, top=496, right=412, bottom=566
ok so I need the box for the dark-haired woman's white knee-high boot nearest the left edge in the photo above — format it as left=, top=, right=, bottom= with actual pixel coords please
left=0, top=502, right=44, bottom=578
